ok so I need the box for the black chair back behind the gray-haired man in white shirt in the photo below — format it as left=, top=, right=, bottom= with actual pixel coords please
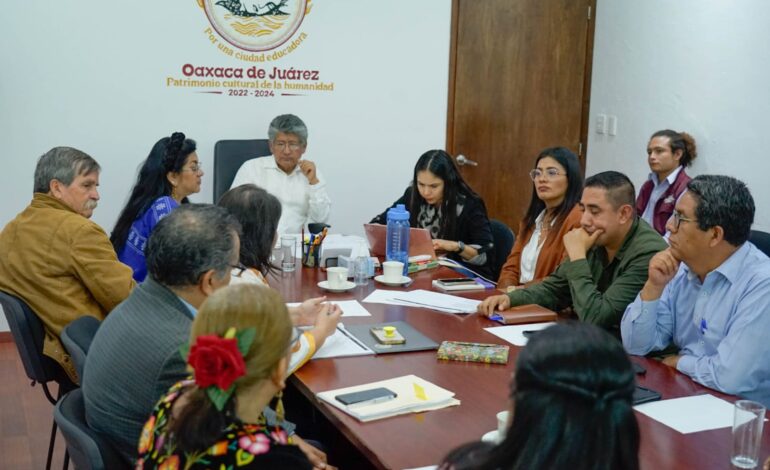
left=214, top=139, right=270, bottom=204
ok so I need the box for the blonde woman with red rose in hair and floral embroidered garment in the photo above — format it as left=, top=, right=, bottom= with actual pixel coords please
left=136, top=284, right=332, bottom=470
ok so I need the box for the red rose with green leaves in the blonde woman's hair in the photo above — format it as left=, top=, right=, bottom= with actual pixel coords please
left=180, top=328, right=257, bottom=411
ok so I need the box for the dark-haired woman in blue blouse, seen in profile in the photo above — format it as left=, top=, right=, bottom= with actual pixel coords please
left=110, top=132, right=203, bottom=282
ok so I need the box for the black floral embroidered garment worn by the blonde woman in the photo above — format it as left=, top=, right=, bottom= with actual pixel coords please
left=136, top=380, right=313, bottom=470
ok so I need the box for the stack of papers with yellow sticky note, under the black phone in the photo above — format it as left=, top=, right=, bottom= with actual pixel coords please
left=318, top=375, right=460, bottom=422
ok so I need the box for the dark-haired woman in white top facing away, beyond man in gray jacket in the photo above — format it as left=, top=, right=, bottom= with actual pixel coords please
left=217, top=184, right=342, bottom=374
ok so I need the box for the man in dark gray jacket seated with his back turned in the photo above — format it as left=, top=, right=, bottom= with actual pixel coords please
left=82, top=204, right=241, bottom=461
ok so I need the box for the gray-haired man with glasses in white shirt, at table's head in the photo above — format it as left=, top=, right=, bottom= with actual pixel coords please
left=231, top=114, right=332, bottom=233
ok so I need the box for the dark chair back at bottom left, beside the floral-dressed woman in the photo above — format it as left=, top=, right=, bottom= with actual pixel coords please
left=53, top=388, right=129, bottom=470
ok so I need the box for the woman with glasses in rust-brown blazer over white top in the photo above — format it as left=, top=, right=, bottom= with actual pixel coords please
left=497, top=147, right=583, bottom=291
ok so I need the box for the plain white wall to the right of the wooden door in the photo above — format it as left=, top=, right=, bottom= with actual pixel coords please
left=586, top=0, right=770, bottom=230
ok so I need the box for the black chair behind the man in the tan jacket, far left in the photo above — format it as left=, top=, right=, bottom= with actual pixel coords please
left=0, top=292, right=77, bottom=470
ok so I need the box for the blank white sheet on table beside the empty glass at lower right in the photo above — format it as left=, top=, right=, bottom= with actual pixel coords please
left=634, top=394, right=734, bottom=434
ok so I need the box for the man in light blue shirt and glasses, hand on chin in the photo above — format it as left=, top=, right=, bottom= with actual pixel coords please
left=620, top=175, right=770, bottom=406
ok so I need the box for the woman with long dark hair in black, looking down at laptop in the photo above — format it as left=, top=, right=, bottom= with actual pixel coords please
left=371, top=150, right=494, bottom=277
